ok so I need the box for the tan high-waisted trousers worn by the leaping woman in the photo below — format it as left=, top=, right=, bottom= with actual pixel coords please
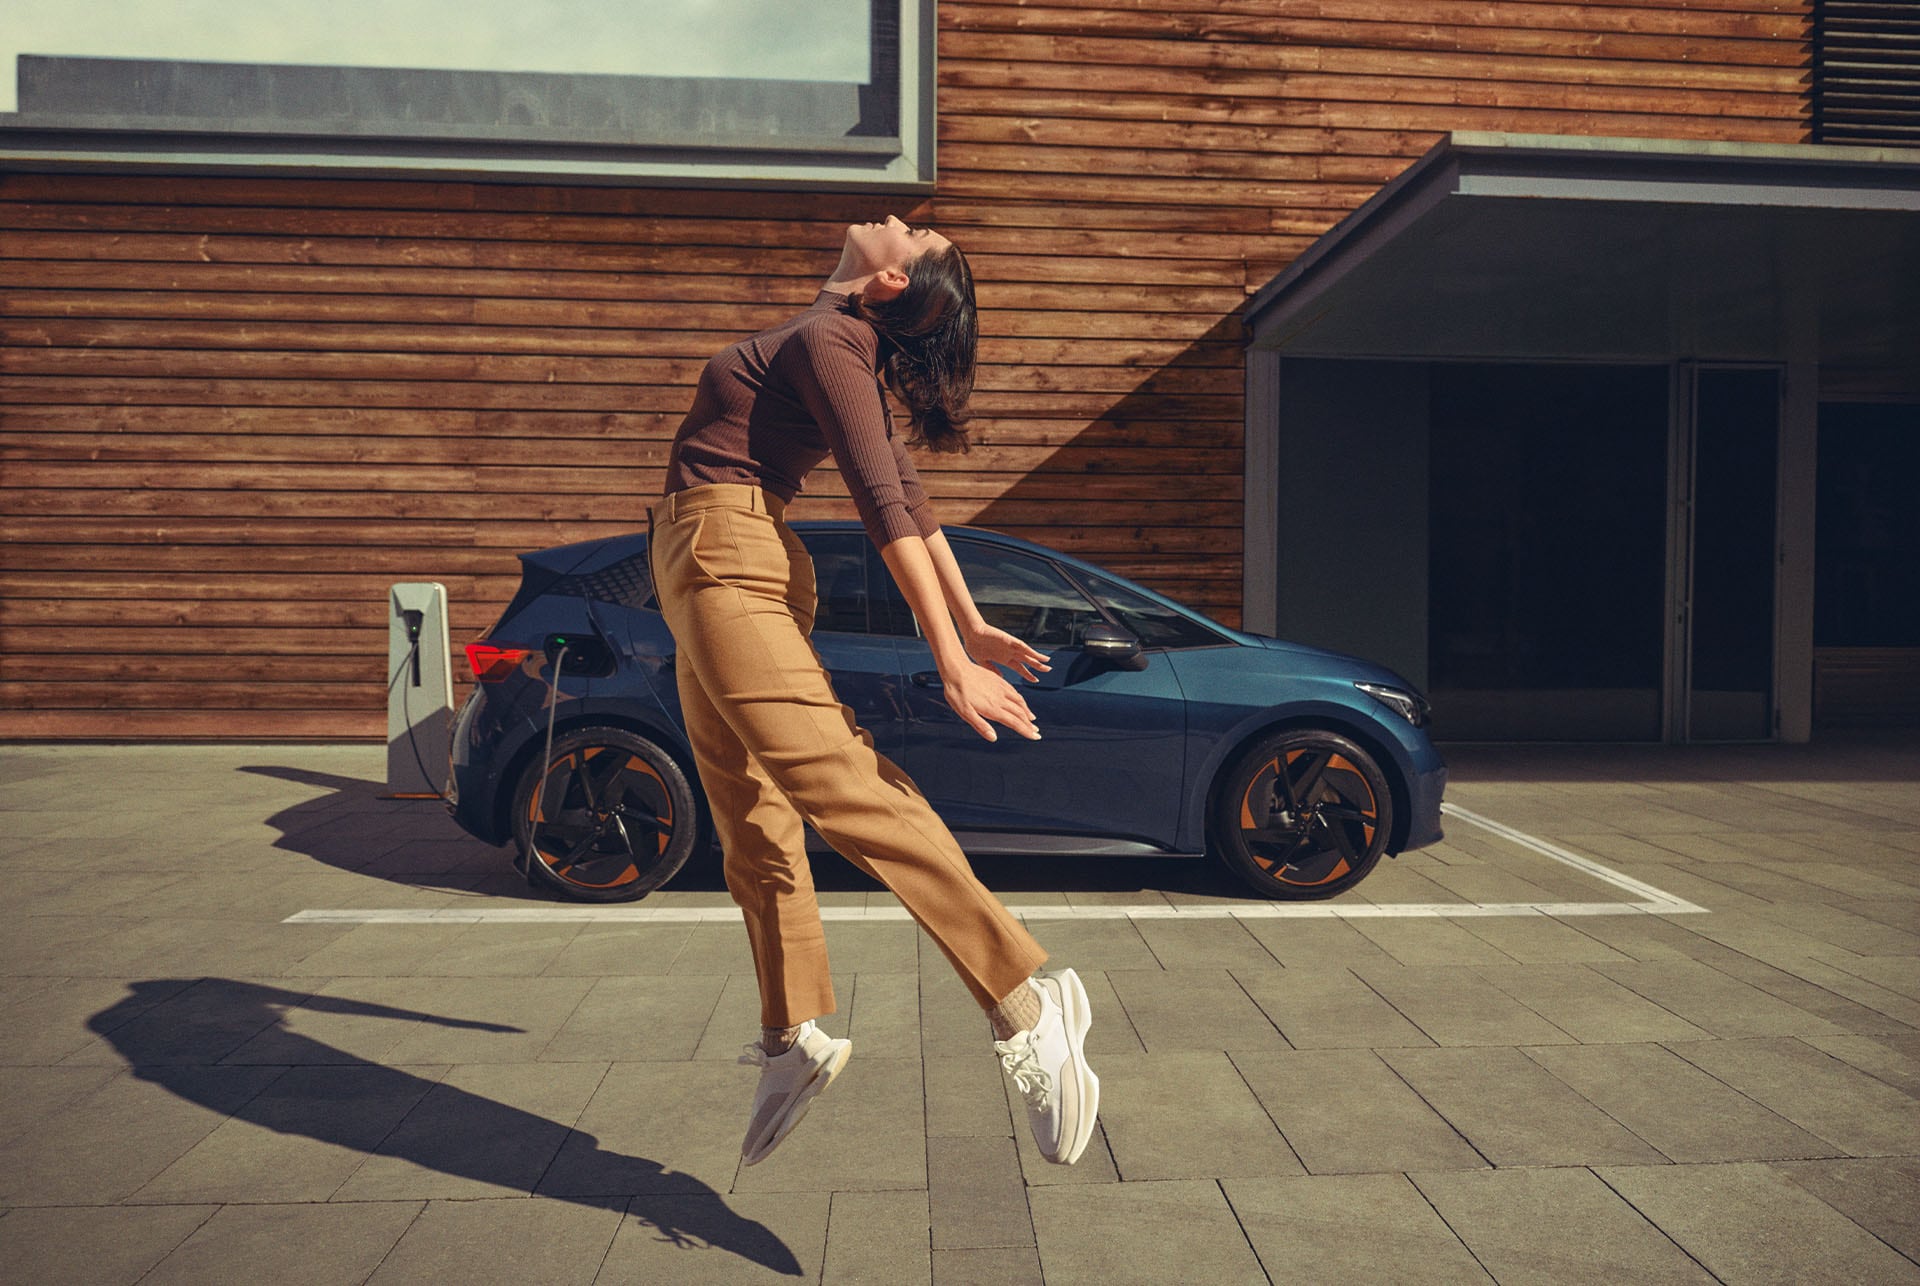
left=651, top=484, right=1046, bottom=1027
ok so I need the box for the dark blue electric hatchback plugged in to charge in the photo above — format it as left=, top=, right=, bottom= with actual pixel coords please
left=447, top=522, right=1446, bottom=902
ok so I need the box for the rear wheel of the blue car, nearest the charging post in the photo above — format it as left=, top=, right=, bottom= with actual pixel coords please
left=513, top=727, right=701, bottom=902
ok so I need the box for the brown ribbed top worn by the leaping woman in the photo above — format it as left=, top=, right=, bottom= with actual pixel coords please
left=666, top=290, right=941, bottom=545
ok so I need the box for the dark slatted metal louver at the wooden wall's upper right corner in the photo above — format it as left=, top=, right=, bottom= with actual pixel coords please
left=1812, top=0, right=1920, bottom=148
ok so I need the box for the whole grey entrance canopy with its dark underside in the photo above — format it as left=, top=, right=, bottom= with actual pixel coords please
left=1246, top=132, right=1920, bottom=390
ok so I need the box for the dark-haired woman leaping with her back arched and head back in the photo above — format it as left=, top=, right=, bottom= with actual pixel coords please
left=651, top=215, right=1100, bottom=1165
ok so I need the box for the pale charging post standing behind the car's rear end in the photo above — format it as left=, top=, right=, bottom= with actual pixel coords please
left=386, top=582, right=453, bottom=798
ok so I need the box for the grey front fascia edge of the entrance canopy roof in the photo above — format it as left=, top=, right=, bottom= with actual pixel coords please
left=1244, top=131, right=1920, bottom=344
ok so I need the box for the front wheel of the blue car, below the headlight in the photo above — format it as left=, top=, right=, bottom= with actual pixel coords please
left=1212, top=727, right=1394, bottom=900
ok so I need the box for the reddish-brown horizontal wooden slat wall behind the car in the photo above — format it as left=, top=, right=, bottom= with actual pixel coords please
left=0, top=0, right=1807, bottom=739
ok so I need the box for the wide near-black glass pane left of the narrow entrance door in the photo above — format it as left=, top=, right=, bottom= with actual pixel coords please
left=1427, top=363, right=1670, bottom=741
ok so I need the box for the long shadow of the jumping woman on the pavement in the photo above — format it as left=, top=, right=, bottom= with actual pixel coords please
left=86, top=979, right=801, bottom=1276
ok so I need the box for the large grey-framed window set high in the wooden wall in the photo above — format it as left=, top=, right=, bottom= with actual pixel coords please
left=0, top=0, right=935, bottom=190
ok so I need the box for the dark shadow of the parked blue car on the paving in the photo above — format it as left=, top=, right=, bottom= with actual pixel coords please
left=240, top=764, right=1260, bottom=902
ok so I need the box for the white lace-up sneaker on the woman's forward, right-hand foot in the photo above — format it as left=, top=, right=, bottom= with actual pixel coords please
left=993, top=969, right=1100, bottom=1165
